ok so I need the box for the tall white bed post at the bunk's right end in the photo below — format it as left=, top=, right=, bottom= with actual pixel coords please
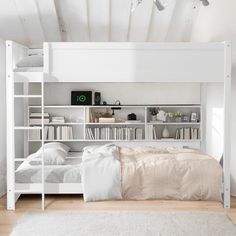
left=223, top=41, right=231, bottom=208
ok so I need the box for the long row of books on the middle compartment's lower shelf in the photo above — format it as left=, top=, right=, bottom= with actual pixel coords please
left=86, top=127, right=143, bottom=140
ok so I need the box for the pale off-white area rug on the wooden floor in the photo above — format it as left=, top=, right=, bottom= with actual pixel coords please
left=11, top=211, right=236, bottom=236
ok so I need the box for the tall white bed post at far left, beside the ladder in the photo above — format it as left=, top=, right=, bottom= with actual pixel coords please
left=6, top=41, right=15, bottom=210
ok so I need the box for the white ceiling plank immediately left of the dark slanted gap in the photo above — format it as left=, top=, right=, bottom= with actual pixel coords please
left=35, top=0, right=62, bottom=42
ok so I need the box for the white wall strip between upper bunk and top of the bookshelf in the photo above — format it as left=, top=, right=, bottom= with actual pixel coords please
left=40, top=83, right=200, bottom=104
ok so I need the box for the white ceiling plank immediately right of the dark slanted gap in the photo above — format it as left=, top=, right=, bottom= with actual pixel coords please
left=56, top=0, right=89, bottom=41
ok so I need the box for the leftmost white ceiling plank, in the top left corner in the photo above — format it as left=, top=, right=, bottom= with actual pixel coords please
left=0, top=0, right=29, bottom=46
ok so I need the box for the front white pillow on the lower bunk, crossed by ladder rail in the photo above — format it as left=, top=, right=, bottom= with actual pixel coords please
left=27, top=148, right=67, bottom=165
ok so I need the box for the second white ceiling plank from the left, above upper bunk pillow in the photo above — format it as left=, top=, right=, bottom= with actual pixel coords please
left=14, top=0, right=45, bottom=47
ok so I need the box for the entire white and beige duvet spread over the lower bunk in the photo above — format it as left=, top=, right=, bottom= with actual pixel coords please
left=82, top=145, right=222, bottom=201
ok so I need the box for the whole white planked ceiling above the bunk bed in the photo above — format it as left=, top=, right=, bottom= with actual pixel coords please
left=0, top=0, right=200, bottom=47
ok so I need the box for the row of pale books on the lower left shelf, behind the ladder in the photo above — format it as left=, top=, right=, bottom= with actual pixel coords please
left=29, top=126, right=73, bottom=140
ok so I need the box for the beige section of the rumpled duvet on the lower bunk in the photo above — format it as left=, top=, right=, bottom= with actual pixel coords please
left=120, top=147, right=222, bottom=201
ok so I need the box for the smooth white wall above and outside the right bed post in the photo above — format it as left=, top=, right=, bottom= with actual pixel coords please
left=192, top=0, right=236, bottom=195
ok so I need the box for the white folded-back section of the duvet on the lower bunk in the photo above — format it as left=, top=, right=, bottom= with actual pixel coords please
left=81, top=144, right=122, bottom=202
